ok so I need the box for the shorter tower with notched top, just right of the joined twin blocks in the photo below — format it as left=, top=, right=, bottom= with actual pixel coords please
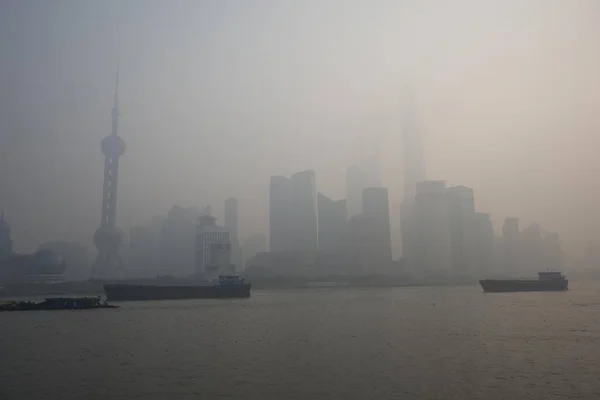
left=317, top=193, right=348, bottom=255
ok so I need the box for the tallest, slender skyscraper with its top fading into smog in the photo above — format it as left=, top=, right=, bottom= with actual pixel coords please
left=400, top=85, right=427, bottom=272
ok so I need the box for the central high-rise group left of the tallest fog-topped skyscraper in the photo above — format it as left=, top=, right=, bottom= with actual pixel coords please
left=258, top=164, right=392, bottom=275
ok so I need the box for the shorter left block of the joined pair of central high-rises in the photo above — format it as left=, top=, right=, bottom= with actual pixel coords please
left=269, top=176, right=291, bottom=252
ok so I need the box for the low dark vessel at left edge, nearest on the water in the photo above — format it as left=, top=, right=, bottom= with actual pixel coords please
left=0, top=297, right=119, bottom=311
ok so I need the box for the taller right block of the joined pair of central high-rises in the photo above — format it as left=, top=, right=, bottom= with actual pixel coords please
left=289, top=170, right=319, bottom=253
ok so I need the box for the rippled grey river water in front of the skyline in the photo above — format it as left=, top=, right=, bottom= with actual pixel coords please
left=0, top=284, right=600, bottom=400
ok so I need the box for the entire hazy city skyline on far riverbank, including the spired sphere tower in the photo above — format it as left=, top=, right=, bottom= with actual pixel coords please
left=0, top=75, right=580, bottom=280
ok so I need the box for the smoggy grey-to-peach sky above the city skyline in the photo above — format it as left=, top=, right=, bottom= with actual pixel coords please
left=0, top=0, right=600, bottom=255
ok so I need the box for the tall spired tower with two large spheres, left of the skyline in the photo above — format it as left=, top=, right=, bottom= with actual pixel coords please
left=92, top=68, right=125, bottom=279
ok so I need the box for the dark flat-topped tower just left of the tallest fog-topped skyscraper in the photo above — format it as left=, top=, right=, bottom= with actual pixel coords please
left=362, top=187, right=392, bottom=269
